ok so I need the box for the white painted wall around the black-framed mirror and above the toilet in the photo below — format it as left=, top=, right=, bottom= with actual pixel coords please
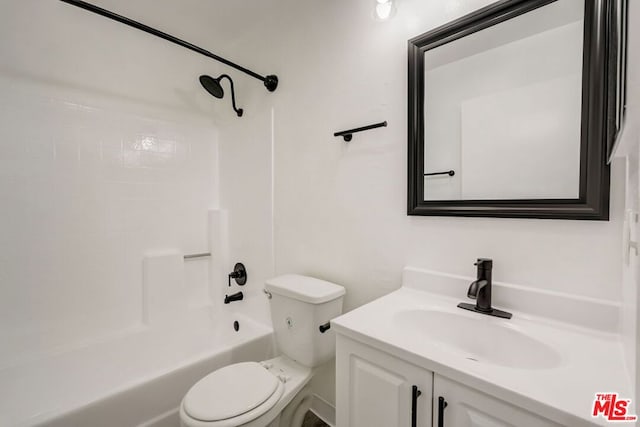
left=224, top=0, right=624, bottom=408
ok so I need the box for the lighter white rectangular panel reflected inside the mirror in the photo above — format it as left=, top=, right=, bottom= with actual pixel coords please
left=460, top=72, right=581, bottom=200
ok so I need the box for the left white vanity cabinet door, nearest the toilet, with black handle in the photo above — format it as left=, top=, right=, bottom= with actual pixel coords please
left=336, top=335, right=433, bottom=427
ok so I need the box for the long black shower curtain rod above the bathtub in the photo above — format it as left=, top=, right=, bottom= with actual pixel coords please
left=60, top=0, right=278, bottom=92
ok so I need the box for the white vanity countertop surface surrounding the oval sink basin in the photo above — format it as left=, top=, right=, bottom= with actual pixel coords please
left=331, top=272, right=632, bottom=426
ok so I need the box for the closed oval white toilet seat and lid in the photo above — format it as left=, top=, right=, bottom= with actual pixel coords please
left=182, top=362, right=284, bottom=427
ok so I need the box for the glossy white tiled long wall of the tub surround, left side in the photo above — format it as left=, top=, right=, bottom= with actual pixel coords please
left=0, top=76, right=221, bottom=370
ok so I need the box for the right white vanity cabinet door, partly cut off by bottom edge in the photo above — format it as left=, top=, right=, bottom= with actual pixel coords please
left=433, top=375, right=560, bottom=427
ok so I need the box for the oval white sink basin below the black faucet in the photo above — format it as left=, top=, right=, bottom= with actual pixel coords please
left=394, top=310, right=562, bottom=369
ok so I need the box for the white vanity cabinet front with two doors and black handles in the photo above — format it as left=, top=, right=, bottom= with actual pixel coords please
left=336, top=334, right=560, bottom=427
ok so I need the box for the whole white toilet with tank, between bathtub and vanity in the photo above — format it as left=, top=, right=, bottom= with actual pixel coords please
left=180, top=274, right=345, bottom=427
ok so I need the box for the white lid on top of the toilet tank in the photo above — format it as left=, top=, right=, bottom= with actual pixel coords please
left=265, top=274, right=345, bottom=304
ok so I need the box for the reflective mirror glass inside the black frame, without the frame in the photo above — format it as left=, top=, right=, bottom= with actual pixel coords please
left=423, top=0, right=584, bottom=200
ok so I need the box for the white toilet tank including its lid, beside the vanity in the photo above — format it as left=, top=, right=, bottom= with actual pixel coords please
left=265, top=274, right=345, bottom=368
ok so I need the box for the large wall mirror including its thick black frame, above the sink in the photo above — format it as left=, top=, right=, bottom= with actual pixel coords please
left=408, top=0, right=620, bottom=220
